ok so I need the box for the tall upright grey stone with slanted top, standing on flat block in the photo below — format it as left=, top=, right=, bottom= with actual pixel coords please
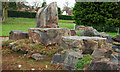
left=36, top=2, right=58, bottom=28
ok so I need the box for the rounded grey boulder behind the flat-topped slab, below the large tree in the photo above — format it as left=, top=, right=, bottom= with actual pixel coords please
left=80, top=28, right=99, bottom=37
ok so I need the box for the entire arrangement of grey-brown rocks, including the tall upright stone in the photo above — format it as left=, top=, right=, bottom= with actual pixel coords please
left=6, top=2, right=120, bottom=70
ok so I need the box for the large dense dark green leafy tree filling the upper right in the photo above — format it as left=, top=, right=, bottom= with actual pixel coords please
left=73, top=2, right=120, bottom=27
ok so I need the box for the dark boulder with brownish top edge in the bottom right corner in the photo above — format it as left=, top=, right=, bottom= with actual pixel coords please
left=85, top=58, right=118, bottom=72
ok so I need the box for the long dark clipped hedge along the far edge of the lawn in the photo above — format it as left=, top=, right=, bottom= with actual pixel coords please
left=8, top=10, right=73, bottom=20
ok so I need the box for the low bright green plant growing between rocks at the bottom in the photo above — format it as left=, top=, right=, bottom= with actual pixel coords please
left=75, top=55, right=94, bottom=70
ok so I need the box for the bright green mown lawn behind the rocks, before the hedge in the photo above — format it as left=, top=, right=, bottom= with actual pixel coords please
left=0, top=18, right=117, bottom=37
